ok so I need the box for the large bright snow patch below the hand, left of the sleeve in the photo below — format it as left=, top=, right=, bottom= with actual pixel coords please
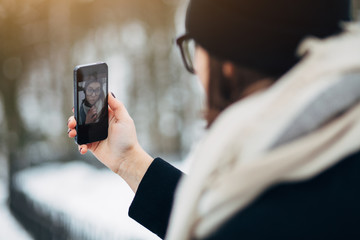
left=13, top=161, right=159, bottom=239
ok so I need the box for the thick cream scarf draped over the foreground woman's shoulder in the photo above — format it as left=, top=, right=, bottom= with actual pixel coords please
left=166, top=25, right=360, bottom=240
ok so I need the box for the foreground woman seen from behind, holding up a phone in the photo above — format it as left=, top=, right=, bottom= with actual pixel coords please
left=68, top=0, right=360, bottom=239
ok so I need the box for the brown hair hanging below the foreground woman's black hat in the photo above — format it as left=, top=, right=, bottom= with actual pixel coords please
left=205, top=55, right=279, bottom=127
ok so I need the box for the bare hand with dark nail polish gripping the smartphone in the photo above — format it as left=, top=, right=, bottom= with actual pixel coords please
left=68, top=94, right=153, bottom=192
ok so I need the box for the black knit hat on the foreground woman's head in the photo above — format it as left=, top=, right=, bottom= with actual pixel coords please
left=186, top=0, right=350, bottom=75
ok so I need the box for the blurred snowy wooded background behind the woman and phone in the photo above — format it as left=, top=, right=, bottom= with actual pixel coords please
left=0, top=0, right=360, bottom=239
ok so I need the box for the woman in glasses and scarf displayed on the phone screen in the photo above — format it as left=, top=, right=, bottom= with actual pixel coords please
left=79, top=75, right=105, bottom=124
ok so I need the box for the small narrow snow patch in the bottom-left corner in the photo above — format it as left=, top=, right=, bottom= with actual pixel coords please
left=0, top=178, right=32, bottom=240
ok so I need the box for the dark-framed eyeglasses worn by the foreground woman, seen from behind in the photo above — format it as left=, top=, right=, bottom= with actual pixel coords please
left=176, top=34, right=196, bottom=74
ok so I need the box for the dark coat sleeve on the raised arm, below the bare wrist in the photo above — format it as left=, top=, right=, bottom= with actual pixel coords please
left=129, top=158, right=182, bottom=238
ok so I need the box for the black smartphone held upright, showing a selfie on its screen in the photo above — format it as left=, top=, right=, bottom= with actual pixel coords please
left=74, top=62, right=109, bottom=144
